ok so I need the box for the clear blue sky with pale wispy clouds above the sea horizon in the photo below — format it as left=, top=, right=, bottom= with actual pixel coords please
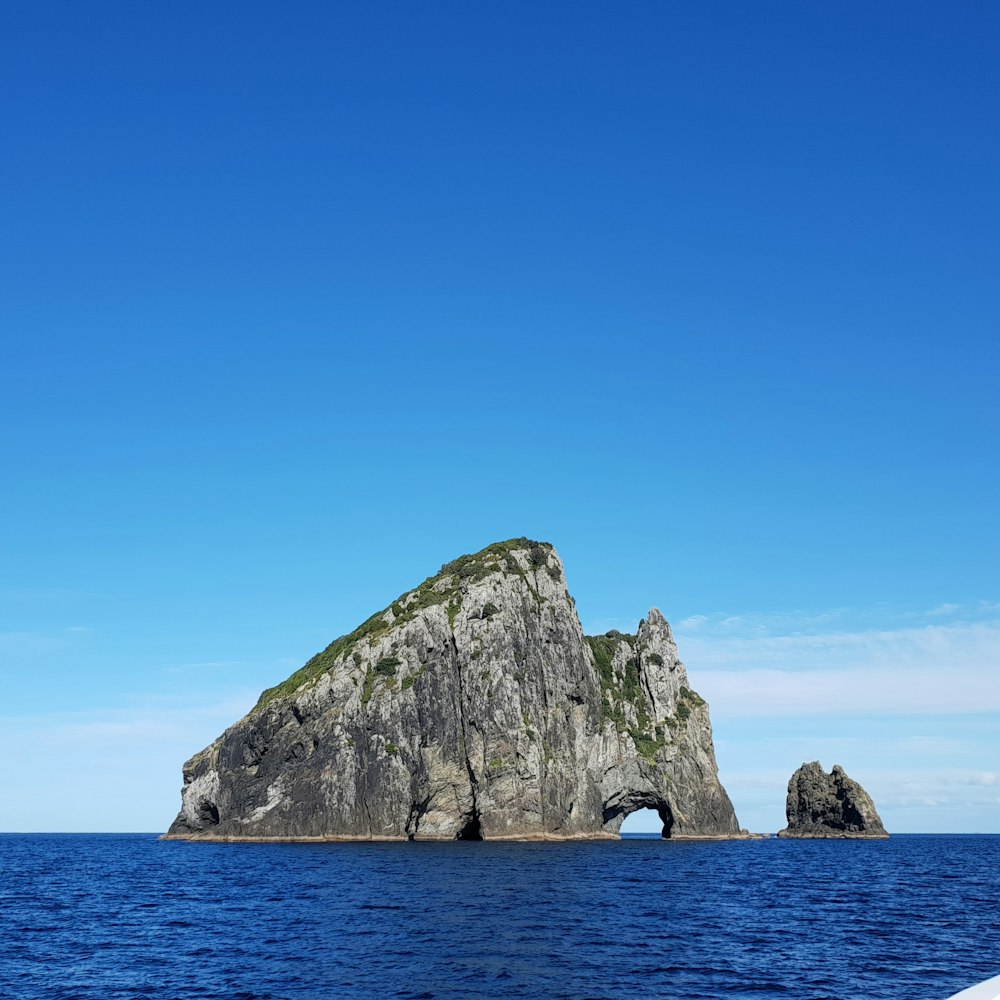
left=0, top=3, right=1000, bottom=831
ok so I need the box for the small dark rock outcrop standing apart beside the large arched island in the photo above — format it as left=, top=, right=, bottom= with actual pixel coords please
left=778, top=761, right=889, bottom=837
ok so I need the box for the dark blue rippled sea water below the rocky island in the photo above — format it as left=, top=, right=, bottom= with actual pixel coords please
left=0, top=834, right=1000, bottom=1000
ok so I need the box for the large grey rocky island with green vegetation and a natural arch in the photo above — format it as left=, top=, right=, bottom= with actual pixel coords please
left=168, top=539, right=740, bottom=840
